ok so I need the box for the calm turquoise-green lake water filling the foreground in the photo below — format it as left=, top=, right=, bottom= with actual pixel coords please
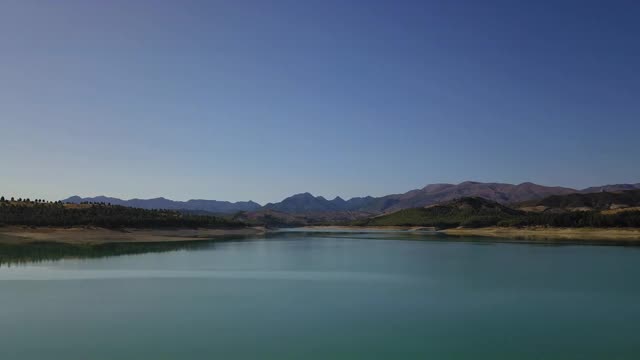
left=0, top=232, right=640, bottom=360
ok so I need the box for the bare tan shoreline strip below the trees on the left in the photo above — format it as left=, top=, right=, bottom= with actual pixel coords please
left=0, top=226, right=266, bottom=244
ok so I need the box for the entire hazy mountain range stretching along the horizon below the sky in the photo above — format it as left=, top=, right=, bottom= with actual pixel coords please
left=62, top=181, right=640, bottom=214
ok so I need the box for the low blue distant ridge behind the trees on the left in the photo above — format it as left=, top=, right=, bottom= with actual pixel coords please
left=62, top=196, right=261, bottom=213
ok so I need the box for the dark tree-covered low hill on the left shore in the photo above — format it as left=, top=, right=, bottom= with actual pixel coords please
left=0, top=198, right=245, bottom=228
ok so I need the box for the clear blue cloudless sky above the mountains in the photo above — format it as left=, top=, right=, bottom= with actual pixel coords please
left=0, top=0, right=640, bottom=203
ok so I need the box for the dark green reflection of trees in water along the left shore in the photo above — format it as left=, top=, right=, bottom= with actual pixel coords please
left=0, top=236, right=255, bottom=267
